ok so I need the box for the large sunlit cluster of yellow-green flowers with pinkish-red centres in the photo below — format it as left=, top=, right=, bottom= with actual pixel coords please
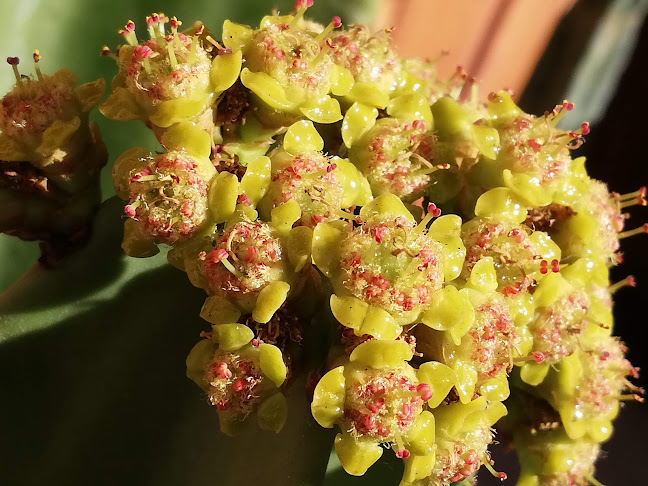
left=102, top=0, right=646, bottom=486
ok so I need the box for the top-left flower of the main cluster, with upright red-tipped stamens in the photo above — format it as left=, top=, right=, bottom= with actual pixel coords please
left=100, top=14, right=242, bottom=136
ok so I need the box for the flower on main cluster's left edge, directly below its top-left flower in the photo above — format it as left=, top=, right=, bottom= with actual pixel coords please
left=113, top=122, right=216, bottom=257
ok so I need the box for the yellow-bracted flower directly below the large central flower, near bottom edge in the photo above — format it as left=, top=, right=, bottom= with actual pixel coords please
left=311, top=340, right=452, bottom=476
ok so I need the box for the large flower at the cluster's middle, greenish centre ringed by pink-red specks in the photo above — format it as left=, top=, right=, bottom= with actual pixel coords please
left=313, top=194, right=463, bottom=339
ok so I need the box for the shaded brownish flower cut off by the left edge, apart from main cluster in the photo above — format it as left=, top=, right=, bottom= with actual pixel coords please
left=0, top=50, right=108, bottom=252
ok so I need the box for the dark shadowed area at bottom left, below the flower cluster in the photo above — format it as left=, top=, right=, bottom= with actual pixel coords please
left=0, top=266, right=332, bottom=486
